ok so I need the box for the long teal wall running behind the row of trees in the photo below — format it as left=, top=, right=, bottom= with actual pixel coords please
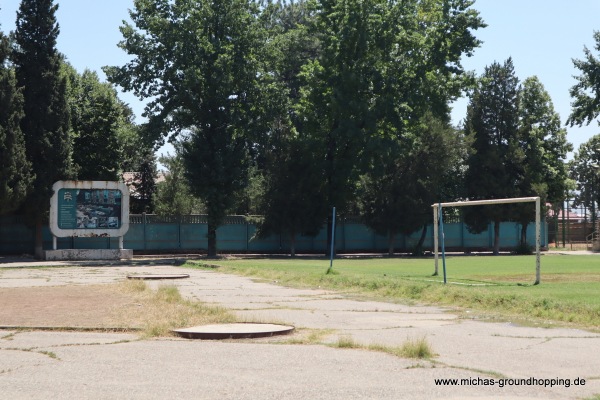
left=0, top=214, right=548, bottom=254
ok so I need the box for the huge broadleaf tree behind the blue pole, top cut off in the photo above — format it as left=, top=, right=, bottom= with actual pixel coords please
left=298, top=0, right=484, bottom=253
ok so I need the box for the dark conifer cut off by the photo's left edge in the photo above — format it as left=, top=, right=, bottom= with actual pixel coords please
left=0, top=23, right=33, bottom=215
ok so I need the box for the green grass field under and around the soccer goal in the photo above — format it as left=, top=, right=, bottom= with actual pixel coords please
left=187, top=255, right=600, bottom=331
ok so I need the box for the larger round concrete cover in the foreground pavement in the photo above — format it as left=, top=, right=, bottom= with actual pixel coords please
left=173, top=323, right=294, bottom=340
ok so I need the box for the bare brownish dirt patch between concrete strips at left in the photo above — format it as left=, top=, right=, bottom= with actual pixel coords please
left=0, top=285, right=139, bottom=328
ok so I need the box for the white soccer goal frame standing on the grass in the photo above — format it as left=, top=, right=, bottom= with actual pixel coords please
left=432, top=197, right=541, bottom=285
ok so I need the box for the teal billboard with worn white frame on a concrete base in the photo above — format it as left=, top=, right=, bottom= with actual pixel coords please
left=46, top=181, right=133, bottom=260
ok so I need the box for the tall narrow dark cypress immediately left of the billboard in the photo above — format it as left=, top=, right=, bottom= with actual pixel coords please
left=13, top=0, right=74, bottom=258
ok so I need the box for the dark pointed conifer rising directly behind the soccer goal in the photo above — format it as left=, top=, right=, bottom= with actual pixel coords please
left=464, top=58, right=525, bottom=254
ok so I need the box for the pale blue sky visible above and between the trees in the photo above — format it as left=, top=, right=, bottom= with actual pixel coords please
left=0, top=0, right=600, bottom=159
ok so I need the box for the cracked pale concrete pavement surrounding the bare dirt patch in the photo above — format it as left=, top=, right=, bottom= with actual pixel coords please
left=0, top=263, right=600, bottom=399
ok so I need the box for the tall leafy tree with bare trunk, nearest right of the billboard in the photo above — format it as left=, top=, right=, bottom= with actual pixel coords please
left=105, top=0, right=264, bottom=256
